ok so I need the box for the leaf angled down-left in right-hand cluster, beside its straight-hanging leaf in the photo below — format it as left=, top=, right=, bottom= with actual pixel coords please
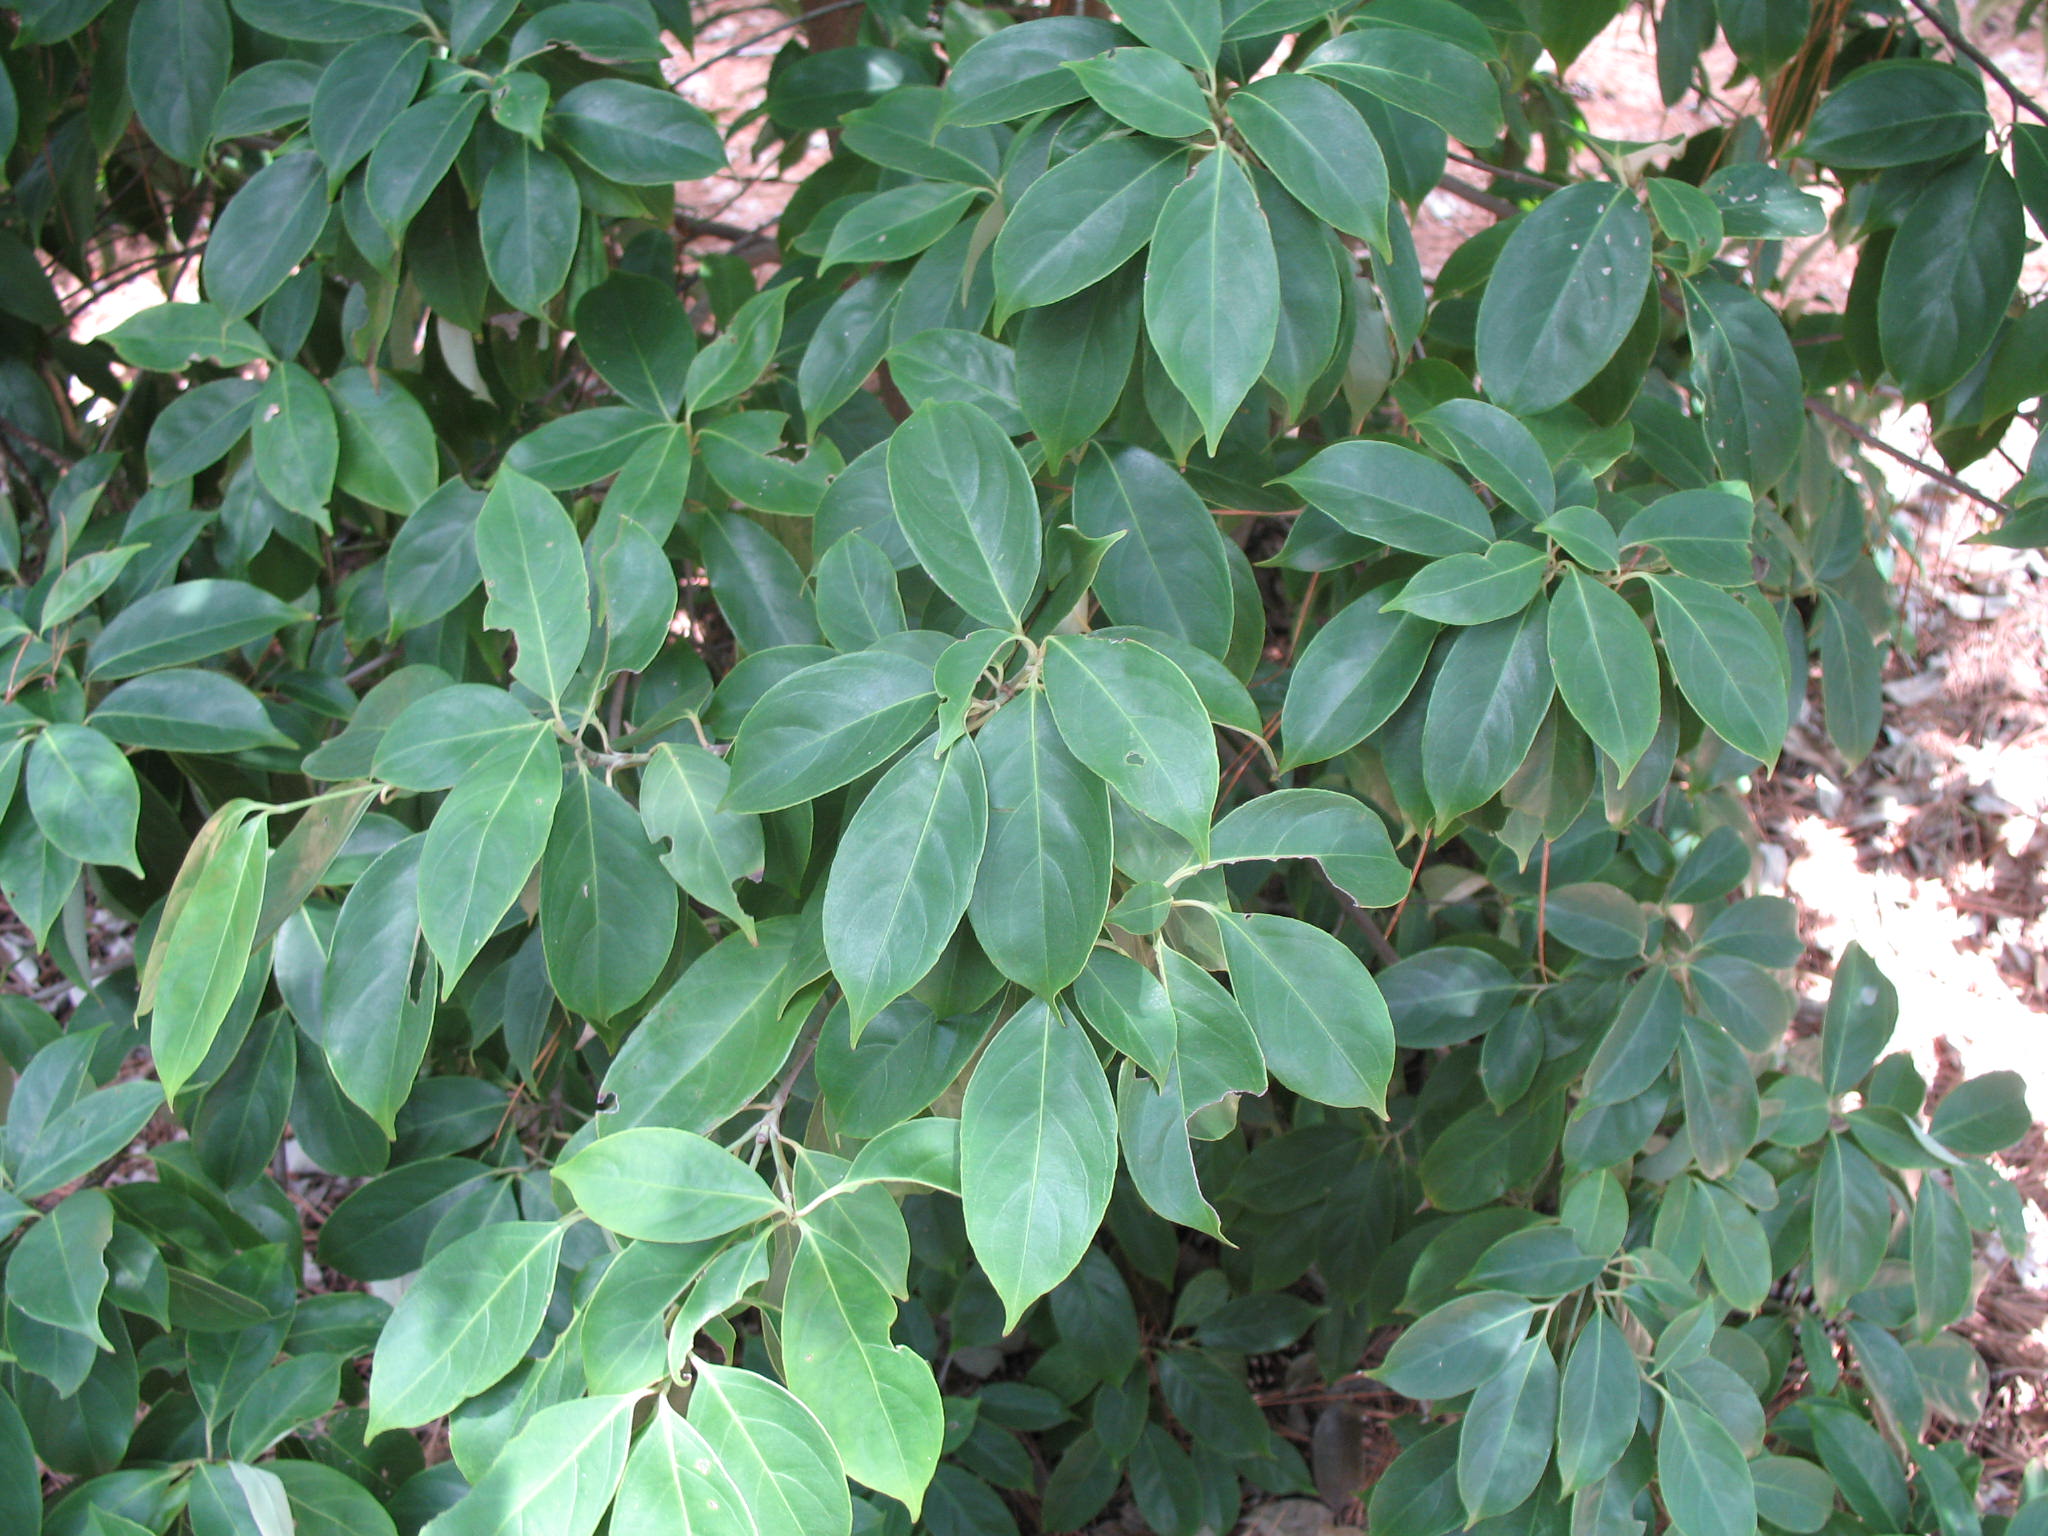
left=1421, top=598, right=1552, bottom=821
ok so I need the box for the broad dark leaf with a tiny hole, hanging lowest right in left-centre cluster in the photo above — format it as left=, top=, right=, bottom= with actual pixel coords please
left=541, top=770, right=676, bottom=1020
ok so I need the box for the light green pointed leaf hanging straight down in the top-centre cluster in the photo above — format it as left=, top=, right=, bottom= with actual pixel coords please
left=1126, top=148, right=1280, bottom=453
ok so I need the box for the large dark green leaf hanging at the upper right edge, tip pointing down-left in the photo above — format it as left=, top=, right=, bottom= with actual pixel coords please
left=1878, top=156, right=2025, bottom=399
